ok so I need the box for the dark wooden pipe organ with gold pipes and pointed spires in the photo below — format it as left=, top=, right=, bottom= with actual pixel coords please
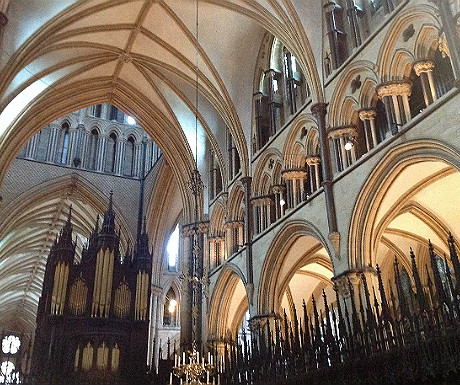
left=31, top=194, right=152, bottom=385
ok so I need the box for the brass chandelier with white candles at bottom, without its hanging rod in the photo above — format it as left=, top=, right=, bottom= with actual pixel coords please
left=169, top=344, right=220, bottom=385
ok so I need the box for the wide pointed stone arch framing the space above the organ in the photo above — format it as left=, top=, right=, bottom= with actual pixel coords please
left=0, top=78, right=198, bottom=218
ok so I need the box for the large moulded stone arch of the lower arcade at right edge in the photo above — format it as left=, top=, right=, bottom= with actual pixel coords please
left=349, top=140, right=460, bottom=268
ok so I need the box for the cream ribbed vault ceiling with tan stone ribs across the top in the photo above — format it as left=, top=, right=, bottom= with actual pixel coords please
left=0, top=0, right=322, bottom=192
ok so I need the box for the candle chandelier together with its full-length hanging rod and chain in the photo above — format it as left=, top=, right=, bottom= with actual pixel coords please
left=169, top=0, right=216, bottom=385
